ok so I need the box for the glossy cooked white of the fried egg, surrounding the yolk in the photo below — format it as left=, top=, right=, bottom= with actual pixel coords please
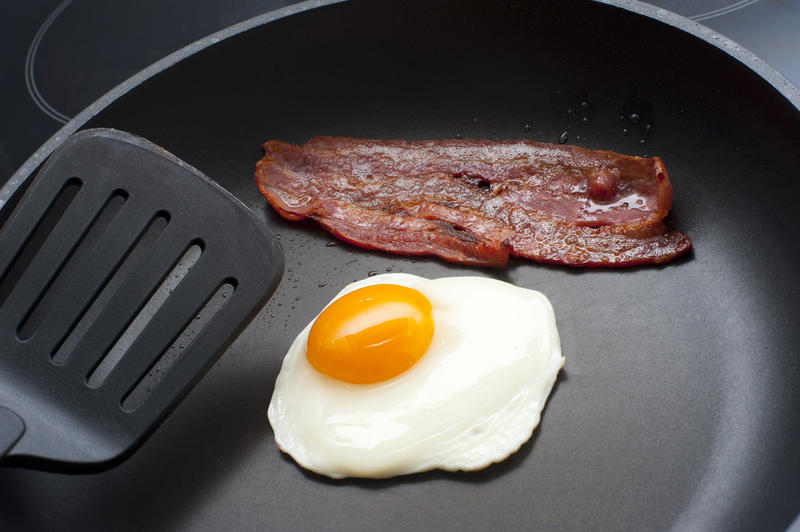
left=268, top=273, right=564, bottom=478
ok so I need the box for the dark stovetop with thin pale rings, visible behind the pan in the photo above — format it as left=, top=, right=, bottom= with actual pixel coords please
left=0, top=0, right=800, bottom=183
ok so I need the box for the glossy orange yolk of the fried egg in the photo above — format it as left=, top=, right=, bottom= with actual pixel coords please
left=306, top=284, right=433, bottom=384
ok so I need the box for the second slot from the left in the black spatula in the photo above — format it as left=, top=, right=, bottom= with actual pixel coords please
left=16, top=190, right=128, bottom=341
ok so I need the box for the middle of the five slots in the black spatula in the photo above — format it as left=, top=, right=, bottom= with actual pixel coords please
left=52, top=211, right=170, bottom=364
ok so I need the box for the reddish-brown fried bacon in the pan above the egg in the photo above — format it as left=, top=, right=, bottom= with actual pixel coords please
left=255, top=137, right=691, bottom=267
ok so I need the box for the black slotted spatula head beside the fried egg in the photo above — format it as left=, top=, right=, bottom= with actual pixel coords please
left=0, top=129, right=283, bottom=471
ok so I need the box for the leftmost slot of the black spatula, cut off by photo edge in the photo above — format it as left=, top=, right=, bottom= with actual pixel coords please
left=0, top=177, right=83, bottom=305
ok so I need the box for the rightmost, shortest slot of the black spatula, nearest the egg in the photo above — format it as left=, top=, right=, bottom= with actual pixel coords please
left=122, top=279, right=237, bottom=412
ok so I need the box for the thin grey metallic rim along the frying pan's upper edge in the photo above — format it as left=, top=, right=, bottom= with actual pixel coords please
left=0, top=0, right=800, bottom=209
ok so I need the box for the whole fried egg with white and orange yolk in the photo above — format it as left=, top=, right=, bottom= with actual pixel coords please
left=268, top=273, right=564, bottom=478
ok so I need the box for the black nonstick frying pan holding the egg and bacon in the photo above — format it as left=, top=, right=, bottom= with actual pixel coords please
left=0, top=0, right=800, bottom=530
